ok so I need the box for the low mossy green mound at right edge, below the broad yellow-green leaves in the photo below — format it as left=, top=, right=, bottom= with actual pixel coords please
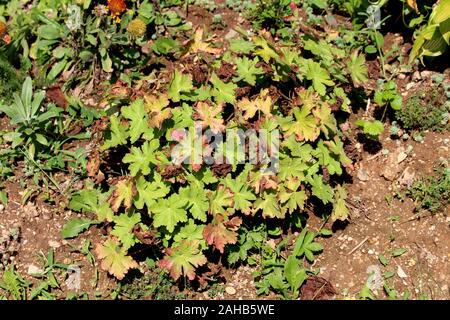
left=396, top=87, right=450, bottom=131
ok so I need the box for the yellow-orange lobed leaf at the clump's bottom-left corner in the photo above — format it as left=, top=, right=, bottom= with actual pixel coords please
left=95, top=239, right=139, bottom=280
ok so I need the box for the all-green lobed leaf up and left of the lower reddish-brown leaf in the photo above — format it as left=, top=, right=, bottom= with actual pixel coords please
left=152, top=194, right=187, bottom=232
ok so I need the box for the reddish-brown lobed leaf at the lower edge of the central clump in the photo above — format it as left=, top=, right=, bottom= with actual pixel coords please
left=203, top=214, right=242, bottom=253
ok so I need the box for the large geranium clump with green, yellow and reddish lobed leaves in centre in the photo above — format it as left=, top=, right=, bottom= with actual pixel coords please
left=67, top=33, right=356, bottom=281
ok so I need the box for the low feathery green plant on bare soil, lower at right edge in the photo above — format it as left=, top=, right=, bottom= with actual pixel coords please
left=408, top=166, right=450, bottom=213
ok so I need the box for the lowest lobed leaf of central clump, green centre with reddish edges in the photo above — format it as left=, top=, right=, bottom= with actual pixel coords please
left=159, top=240, right=207, bottom=280
